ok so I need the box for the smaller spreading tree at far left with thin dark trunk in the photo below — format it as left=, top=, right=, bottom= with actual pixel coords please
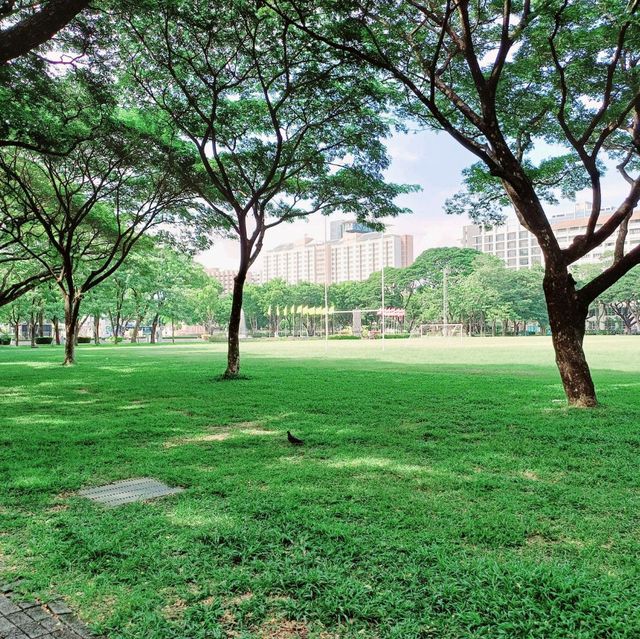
left=0, top=127, right=195, bottom=365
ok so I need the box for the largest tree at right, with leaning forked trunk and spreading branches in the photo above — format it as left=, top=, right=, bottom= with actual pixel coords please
left=276, top=0, right=640, bottom=406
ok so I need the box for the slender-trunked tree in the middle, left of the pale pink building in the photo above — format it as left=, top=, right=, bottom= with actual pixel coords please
left=117, top=0, right=407, bottom=378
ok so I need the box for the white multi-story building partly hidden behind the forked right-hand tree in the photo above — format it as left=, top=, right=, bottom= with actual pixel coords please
left=462, top=202, right=640, bottom=269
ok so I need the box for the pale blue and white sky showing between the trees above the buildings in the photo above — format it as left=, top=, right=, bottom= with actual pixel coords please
left=196, top=131, right=626, bottom=272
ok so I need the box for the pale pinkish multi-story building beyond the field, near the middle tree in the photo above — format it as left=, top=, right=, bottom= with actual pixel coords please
left=262, top=222, right=413, bottom=284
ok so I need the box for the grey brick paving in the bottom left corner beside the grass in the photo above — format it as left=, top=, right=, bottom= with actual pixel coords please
left=0, top=584, right=96, bottom=639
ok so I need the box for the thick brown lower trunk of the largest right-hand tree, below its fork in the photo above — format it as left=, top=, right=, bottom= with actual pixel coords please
left=544, top=267, right=597, bottom=407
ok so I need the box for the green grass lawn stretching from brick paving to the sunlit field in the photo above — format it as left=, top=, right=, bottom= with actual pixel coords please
left=0, top=337, right=640, bottom=639
